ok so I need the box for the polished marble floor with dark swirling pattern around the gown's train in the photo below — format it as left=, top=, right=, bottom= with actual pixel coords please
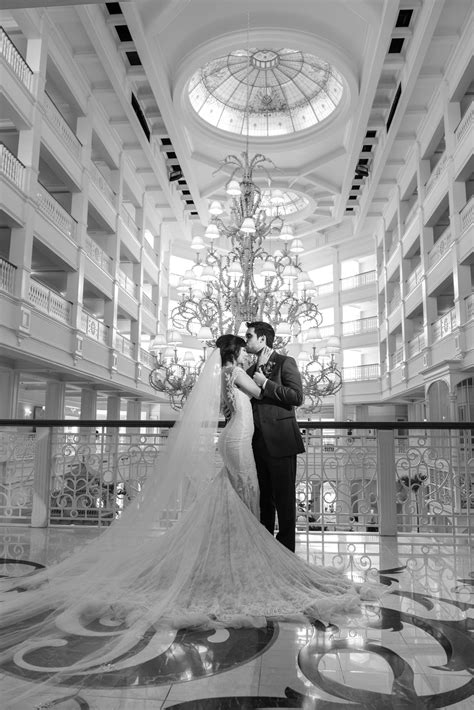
left=0, top=527, right=474, bottom=710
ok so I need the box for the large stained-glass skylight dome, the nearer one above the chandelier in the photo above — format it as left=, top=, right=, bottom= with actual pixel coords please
left=188, top=49, right=344, bottom=137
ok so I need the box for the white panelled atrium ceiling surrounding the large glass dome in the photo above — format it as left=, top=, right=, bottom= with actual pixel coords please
left=0, top=0, right=471, bottom=268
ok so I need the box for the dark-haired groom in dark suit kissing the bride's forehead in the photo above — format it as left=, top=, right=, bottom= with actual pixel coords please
left=245, top=321, right=304, bottom=552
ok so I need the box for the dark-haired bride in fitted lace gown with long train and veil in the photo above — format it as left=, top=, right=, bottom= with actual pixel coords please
left=0, top=335, right=378, bottom=700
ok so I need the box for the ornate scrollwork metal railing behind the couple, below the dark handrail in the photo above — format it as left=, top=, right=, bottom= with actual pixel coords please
left=0, top=419, right=468, bottom=545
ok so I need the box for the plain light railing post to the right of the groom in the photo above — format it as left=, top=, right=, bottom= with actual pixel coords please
left=377, top=429, right=397, bottom=536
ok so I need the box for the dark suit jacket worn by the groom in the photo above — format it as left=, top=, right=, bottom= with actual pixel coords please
left=247, top=352, right=304, bottom=458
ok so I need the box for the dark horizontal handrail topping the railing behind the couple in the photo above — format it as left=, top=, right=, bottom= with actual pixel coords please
left=0, top=419, right=468, bottom=431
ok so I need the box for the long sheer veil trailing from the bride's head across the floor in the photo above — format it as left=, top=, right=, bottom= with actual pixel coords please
left=0, top=350, right=221, bottom=699
